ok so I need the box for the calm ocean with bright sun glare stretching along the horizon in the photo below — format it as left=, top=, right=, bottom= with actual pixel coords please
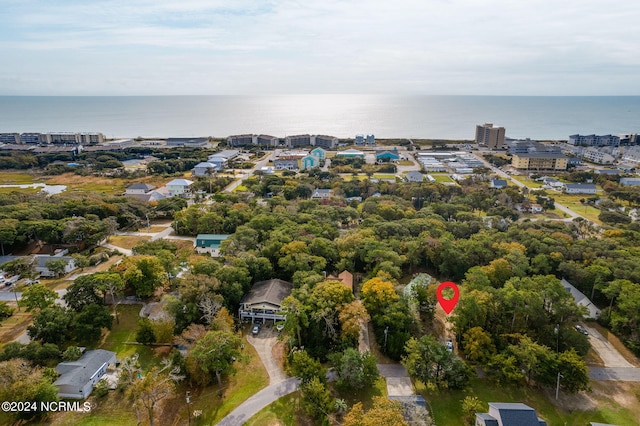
left=0, top=95, right=640, bottom=139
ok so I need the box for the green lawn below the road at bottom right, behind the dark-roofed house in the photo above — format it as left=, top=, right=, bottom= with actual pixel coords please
left=416, top=379, right=638, bottom=426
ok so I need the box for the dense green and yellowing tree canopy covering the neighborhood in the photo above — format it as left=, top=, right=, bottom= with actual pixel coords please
left=0, top=145, right=640, bottom=424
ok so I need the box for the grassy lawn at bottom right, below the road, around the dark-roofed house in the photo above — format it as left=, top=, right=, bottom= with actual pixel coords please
left=416, top=379, right=640, bottom=426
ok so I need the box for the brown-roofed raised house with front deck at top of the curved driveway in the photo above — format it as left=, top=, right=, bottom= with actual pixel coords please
left=238, top=278, right=293, bottom=323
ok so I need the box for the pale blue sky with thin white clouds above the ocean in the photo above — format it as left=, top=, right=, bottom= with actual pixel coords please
left=0, top=0, right=640, bottom=95
